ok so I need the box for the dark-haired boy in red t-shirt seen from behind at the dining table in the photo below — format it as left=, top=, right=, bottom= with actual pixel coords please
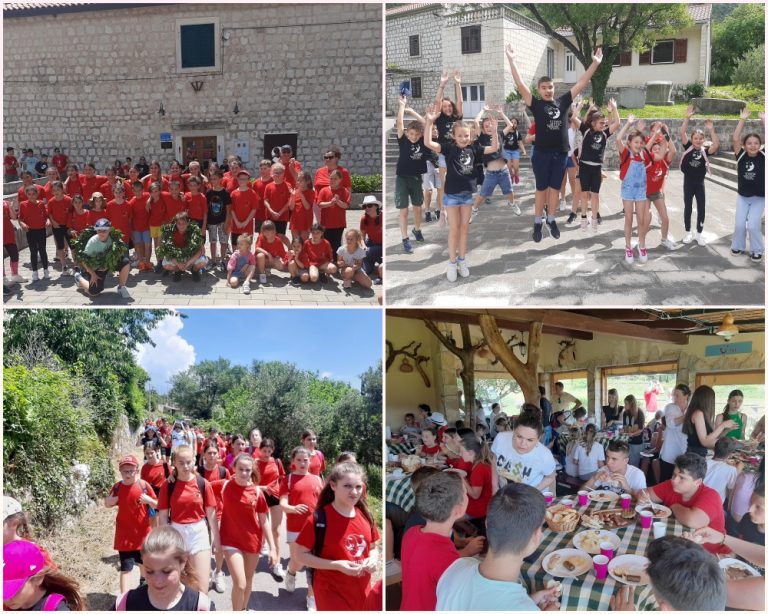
left=400, top=471, right=468, bottom=611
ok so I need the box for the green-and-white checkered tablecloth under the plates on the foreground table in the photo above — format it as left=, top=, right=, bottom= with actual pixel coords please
left=520, top=502, right=685, bottom=611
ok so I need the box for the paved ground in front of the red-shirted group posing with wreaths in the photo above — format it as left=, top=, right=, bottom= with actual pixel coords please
left=3, top=210, right=381, bottom=307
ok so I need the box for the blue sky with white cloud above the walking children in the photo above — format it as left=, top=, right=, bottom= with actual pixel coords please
left=137, top=308, right=382, bottom=393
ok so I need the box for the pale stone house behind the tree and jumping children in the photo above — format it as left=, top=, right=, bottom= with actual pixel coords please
left=386, top=4, right=712, bottom=117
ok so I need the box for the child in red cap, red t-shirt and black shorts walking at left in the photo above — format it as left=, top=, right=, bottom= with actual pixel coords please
left=104, top=454, right=157, bottom=593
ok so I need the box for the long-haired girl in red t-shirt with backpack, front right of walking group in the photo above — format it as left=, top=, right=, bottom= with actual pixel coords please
left=296, top=463, right=379, bottom=610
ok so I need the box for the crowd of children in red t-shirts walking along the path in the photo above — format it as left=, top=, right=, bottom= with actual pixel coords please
left=3, top=420, right=381, bottom=611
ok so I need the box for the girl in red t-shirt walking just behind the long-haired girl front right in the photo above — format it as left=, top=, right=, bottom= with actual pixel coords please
left=280, top=446, right=323, bottom=598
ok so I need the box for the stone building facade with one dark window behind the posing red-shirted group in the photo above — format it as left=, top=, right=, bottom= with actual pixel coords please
left=3, top=2, right=382, bottom=174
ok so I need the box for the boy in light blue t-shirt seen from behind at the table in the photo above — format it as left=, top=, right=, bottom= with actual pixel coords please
left=437, top=483, right=560, bottom=611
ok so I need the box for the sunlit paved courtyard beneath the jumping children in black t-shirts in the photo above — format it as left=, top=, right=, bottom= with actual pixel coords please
left=384, top=167, right=765, bottom=307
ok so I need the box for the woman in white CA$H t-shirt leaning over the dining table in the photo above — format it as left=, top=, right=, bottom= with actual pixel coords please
left=491, top=403, right=557, bottom=492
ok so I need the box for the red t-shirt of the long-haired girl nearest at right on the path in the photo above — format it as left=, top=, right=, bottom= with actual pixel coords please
left=296, top=504, right=379, bottom=610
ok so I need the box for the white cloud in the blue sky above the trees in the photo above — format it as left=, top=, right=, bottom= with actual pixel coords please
left=136, top=316, right=195, bottom=393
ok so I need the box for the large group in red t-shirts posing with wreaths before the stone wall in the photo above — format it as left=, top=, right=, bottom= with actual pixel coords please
left=3, top=146, right=383, bottom=298
